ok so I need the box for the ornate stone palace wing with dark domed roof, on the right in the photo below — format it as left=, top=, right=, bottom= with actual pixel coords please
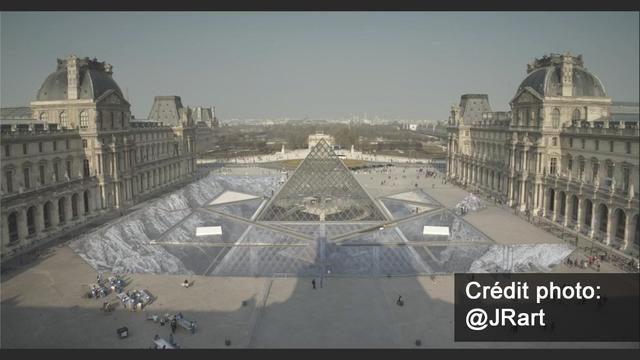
left=447, top=53, right=640, bottom=256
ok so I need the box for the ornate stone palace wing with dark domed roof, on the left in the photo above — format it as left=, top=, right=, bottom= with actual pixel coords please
left=0, top=56, right=196, bottom=260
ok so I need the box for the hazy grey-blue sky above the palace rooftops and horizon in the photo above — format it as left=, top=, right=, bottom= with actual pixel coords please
left=0, top=12, right=640, bottom=120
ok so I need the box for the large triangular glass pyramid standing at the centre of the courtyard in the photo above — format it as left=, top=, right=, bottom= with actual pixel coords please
left=258, top=140, right=387, bottom=221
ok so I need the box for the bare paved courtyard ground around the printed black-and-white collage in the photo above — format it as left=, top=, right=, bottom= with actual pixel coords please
left=0, top=168, right=638, bottom=348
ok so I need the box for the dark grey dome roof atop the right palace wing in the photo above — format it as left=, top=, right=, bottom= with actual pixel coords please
left=518, top=55, right=607, bottom=97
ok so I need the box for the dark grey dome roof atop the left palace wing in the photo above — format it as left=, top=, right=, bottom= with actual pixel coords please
left=37, top=58, right=122, bottom=101
